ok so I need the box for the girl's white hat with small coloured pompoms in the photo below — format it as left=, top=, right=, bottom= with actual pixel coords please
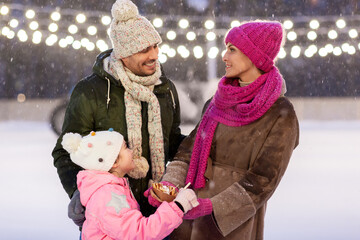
left=61, top=129, right=124, bottom=171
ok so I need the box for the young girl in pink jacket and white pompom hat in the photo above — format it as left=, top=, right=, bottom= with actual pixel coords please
left=62, top=129, right=199, bottom=240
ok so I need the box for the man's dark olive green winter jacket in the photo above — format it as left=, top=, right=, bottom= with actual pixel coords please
left=52, top=50, right=183, bottom=214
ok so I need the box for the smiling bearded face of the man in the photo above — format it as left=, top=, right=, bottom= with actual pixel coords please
left=121, top=44, right=159, bottom=76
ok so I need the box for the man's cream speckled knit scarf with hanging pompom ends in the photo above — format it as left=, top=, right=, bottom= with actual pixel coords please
left=108, top=53, right=165, bottom=181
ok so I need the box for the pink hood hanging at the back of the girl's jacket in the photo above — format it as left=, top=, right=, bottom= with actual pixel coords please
left=77, top=170, right=126, bottom=207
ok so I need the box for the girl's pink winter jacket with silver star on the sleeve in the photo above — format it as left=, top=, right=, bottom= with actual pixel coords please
left=77, top=170, right=183, bottom=240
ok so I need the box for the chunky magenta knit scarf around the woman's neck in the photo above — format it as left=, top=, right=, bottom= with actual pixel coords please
left=186, top=67, right=283, bottom=189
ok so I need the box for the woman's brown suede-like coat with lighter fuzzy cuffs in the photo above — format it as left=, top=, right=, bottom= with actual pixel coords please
left=162, top=97, right=299, bottom=240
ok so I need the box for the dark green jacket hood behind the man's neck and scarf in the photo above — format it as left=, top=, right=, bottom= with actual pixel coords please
left=93, top=49, right=169, bottom=94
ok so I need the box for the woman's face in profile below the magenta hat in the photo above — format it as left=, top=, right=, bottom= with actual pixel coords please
left=222, top=43, right=256, bottom=80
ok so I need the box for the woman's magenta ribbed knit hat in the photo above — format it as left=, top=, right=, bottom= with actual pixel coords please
left=225, top=21, right=284, bottom=72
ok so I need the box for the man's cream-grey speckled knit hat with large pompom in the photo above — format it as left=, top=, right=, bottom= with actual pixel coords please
left=110, top=0, right=161, bottom=59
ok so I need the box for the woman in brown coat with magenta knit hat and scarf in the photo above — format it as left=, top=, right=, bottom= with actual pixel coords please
left=145, top=21, right=299, bottom=240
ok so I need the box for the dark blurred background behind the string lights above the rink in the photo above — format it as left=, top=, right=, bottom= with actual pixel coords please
left=0, top=0, right=360, bottom=99
